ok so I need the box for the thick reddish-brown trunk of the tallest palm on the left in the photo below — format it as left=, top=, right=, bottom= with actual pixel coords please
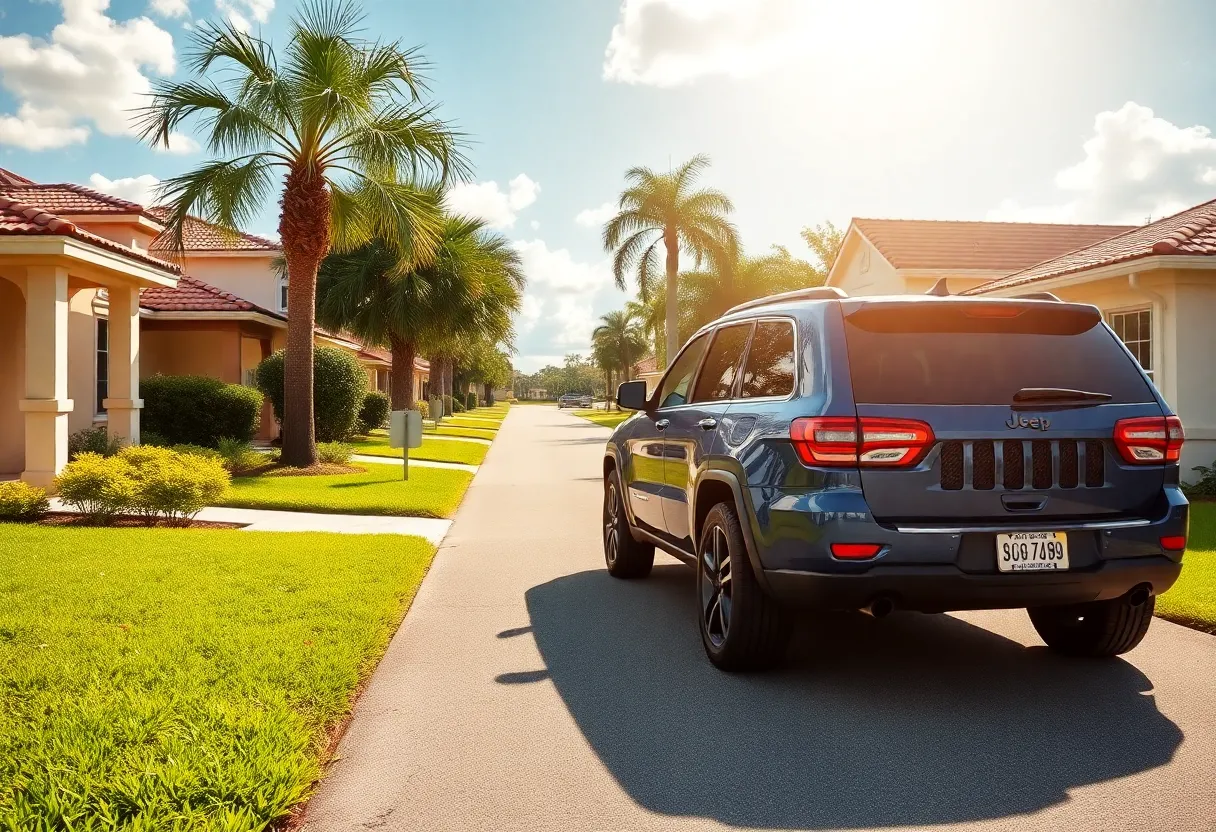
left=278, top=167, right=330, bottom=468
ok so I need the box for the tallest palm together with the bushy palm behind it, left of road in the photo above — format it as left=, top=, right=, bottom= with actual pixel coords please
left=139, top=0, right=524, bottom=467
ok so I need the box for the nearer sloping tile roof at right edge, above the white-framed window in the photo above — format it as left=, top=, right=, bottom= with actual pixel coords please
left=964, top=199, right=1216, bottom=294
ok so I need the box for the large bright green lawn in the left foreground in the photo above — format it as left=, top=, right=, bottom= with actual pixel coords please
left=0, top=524, right=435, bottom=832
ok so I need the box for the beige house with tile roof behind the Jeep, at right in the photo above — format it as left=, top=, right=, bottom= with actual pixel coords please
left=827, top=208, right=1216, bottom=479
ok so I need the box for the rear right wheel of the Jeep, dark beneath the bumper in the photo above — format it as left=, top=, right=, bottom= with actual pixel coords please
left=1026, top=595, right=1156, bottom=657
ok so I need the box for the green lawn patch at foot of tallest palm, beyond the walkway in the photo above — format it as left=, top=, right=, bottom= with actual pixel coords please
left=216, top=464, right=469, bottom=517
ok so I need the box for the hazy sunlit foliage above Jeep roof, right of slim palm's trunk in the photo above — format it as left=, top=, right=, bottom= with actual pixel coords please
left=680, top=246, right=824, bottom=337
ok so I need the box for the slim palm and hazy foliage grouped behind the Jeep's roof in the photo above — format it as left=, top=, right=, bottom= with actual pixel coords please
left=592, top=154, right=843, bottom=388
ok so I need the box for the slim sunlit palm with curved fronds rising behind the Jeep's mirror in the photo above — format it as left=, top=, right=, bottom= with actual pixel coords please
left=603, top=154, right=738, bottom=361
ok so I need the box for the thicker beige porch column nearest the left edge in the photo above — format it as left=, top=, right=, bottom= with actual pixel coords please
left=18, top=266, right=72, bottom=488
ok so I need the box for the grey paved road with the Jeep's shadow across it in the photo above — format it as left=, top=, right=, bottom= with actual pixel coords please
left=299, top=407, right=1216, bottom=832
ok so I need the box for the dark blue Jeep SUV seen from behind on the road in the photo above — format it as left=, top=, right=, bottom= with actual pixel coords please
left=603, top=288, right=1188, bottom=670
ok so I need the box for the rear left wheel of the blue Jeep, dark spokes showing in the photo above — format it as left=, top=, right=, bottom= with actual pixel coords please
left=697, top=502, right=789, bottom=670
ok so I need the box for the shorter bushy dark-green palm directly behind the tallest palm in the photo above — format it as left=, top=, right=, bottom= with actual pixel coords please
left=316, top=212, right=524, bottom=410
